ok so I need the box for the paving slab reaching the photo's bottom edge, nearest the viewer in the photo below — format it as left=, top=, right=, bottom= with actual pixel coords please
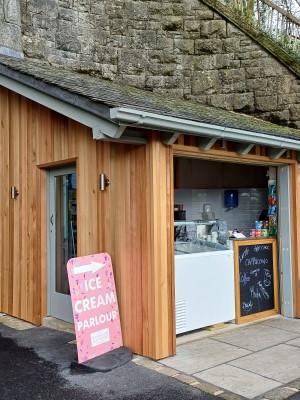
left=194, top=364, right=281, bottom=399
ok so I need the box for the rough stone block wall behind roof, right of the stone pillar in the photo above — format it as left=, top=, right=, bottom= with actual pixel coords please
left=18, top=0, right=300, bottom=128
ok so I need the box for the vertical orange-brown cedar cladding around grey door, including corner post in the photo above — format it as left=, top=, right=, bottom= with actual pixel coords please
left=0, top=88, right=175, bottom=358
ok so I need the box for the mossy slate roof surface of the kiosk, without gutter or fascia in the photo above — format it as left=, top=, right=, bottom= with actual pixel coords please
left=0, top=56, right=300, bottom=141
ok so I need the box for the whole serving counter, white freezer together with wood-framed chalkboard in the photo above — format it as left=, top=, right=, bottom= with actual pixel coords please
left=174, top=221, right=278, bottom=334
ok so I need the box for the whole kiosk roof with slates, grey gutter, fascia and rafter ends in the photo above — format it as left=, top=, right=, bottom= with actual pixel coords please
left=0, top=56, right=300, bottom=158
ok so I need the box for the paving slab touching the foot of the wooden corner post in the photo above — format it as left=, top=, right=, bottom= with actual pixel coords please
left=160, top=339, right=251, bottom=374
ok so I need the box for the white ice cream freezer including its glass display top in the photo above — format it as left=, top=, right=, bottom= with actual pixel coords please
left=174, top=221, right=235, bottom=334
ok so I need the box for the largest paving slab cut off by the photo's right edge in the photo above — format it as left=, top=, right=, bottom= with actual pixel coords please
left=229, top=344, right=300, bottom=383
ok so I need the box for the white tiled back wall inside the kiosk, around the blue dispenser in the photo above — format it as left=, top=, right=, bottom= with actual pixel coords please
left=174, top=188, right=268, bottom=236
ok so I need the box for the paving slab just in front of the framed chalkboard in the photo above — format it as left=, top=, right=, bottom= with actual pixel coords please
left=212, top=324, right=299, bottom=351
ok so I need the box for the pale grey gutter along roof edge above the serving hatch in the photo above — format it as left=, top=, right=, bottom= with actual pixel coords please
left=110, top=107, right=300, bottom=150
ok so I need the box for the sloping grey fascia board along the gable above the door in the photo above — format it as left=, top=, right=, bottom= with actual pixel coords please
left=0, top=75, right=125, bottom=137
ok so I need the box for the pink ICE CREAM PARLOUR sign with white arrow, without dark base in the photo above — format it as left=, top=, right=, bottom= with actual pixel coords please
left=67, top=253, right=123, bottom=363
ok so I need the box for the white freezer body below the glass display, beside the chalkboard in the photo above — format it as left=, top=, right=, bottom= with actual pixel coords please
left=175, top=245, right=235, bottom=334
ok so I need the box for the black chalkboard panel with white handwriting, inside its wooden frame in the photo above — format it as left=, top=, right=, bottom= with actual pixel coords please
left=238, top=241, right=275, bottom=317
